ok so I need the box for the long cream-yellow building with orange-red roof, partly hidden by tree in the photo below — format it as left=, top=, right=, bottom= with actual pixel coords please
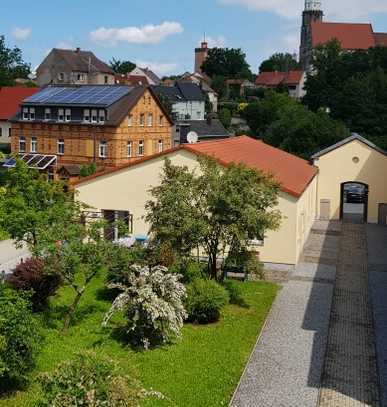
left=76, top=136, right=317, bottom=266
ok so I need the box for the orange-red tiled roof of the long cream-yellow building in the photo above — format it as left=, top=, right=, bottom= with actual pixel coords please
left=182, top=136, right=317, bottom=197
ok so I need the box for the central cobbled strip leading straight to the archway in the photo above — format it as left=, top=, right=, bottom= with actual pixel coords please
left=318, top=223, right=379, bottom=407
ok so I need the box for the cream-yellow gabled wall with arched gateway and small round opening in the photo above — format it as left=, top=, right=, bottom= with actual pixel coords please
left=314, top=140, right=387, bottom=223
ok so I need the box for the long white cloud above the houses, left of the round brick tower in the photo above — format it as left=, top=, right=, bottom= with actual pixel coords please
left=90, top=21, right=183, bottom=46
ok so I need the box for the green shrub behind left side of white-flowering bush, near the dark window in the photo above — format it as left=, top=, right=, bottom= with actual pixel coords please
left=107, top=244, right=146, bottom=283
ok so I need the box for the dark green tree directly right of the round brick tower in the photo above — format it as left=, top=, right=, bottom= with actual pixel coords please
left=201, top=48, right=252, bottom=79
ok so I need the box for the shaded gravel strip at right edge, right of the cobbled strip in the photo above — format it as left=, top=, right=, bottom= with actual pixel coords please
left=367, top=225, right=387, bottom=407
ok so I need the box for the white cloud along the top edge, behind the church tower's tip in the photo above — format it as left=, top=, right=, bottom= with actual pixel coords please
left=218, top=0, right=387, bottom=20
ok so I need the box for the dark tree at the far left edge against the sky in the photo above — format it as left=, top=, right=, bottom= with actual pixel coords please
left=0, top=35, right=31, bottom=87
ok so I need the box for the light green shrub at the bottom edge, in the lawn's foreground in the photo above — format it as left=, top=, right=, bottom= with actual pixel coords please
left=37, top=352, right=162, bottom=407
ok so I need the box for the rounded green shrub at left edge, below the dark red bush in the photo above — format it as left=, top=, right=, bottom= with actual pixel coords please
left=0, top=284, right=39, bottom=393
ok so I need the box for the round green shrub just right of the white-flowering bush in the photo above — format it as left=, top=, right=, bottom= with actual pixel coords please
left=186, top=278, right=229, bottom=324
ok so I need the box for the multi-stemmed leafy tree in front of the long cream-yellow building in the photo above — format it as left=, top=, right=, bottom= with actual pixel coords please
left=146, top=157, right=280, bottom=280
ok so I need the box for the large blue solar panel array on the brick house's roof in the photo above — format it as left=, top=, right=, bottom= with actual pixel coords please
left=24, top=85, right=133, bottom=107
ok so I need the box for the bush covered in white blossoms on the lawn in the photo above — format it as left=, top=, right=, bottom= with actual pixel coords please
left=103, top=266, right=187, bottom=349
